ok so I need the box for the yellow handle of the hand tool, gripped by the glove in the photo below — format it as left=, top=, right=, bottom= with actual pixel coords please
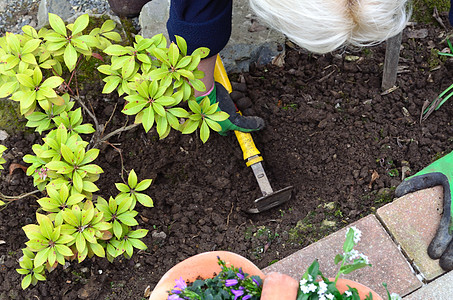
left=214, top=55, right=263, bottom=167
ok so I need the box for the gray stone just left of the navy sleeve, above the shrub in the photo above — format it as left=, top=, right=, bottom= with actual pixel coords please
left=138, top=0, right=170, bottom=40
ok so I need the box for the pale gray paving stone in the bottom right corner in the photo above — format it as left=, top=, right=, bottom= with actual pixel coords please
left=404, top=271, right=453, bottom=300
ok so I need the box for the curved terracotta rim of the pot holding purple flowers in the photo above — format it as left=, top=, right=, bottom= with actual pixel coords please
left=149, top=251, right=264, bottom=300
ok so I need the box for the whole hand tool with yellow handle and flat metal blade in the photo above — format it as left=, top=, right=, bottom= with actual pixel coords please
left=214, top=56, right=293, bottom=214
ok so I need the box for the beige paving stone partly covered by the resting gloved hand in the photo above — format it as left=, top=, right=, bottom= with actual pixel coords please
left=377, top=186, right=444, bottom=282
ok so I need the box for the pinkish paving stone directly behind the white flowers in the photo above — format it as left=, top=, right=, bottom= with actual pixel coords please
left=263, top=215, right=422, bottom=298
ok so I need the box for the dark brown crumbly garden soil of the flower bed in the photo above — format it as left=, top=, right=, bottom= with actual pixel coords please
left=0, top=15, right=453, bottom=299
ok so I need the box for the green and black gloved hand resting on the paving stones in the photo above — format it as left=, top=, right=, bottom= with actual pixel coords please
left=395, top=152, right=453, bottom=271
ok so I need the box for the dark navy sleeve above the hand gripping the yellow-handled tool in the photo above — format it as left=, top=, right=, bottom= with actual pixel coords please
left=167, top=0, right=231, bottom=57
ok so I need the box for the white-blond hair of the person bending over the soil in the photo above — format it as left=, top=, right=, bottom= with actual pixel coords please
left=250, top=0, right=410, bottom=53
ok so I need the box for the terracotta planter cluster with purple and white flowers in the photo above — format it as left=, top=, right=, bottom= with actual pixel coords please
left=150, top=227, right=401, bottom=300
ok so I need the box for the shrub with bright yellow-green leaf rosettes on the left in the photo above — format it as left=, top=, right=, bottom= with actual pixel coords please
left=0, top=14, right=228, bottom=289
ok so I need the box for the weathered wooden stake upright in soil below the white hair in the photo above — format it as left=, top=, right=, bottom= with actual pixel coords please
left=382, top=32, right=403, bottom=90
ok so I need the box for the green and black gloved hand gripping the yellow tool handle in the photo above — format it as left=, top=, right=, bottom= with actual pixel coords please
left=197, top=82, right=264, bottom=136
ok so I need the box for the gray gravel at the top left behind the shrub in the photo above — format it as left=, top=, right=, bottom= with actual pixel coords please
left=0, top=0, right=110, bottom=36
